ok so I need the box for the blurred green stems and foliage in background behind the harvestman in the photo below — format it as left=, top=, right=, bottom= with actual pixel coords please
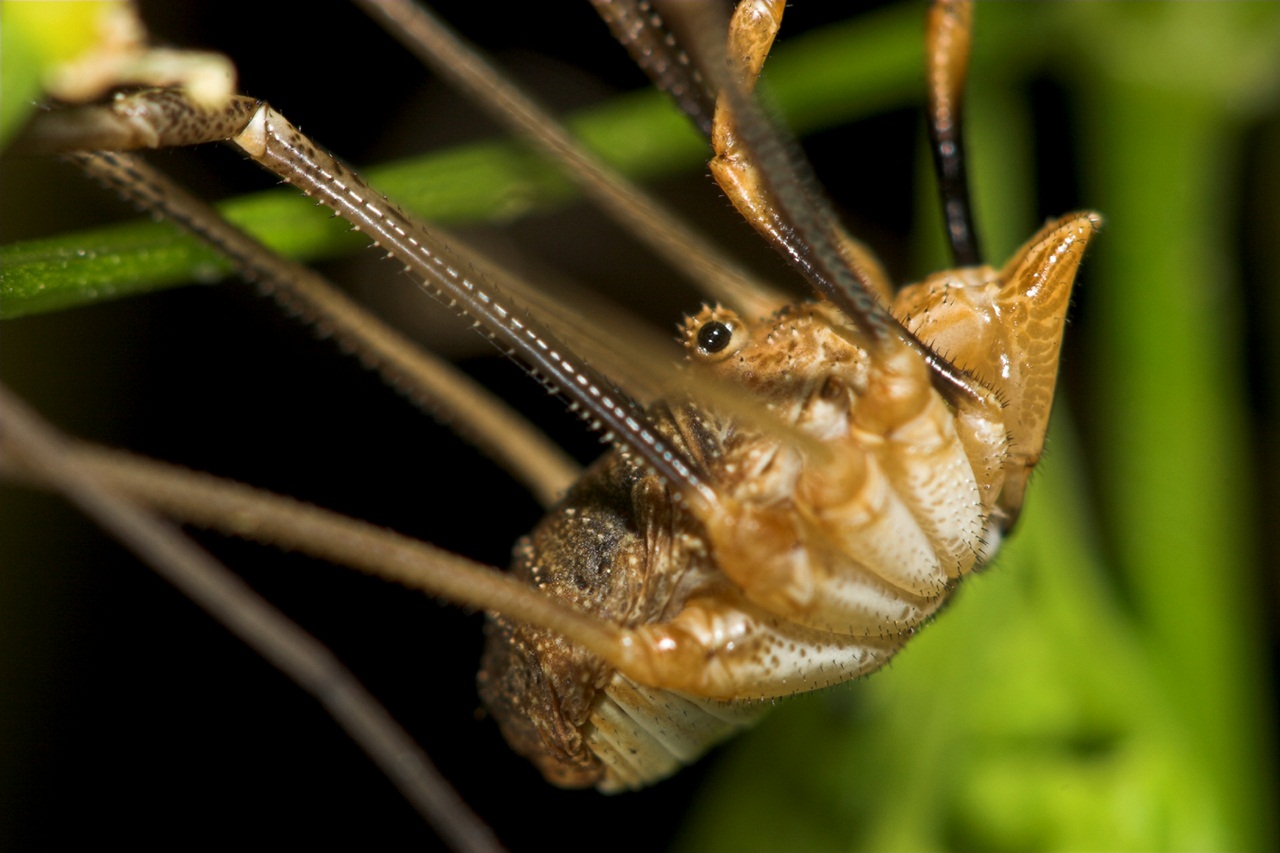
left=0, top=3, right=1280, bottom=850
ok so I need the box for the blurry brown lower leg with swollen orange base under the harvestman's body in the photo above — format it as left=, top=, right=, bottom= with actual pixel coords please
left=0, top=417, right=893, bottom=701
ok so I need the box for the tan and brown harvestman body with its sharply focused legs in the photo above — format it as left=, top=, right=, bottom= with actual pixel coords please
left=2, top=3, right=1098, bottom=824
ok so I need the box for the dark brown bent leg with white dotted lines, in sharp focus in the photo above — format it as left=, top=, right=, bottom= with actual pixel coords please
left=22, top=90, right=716, bottom=505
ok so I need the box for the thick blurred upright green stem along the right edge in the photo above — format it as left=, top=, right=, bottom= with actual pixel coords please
left=1085, top=71, right=1274, bottom=849
